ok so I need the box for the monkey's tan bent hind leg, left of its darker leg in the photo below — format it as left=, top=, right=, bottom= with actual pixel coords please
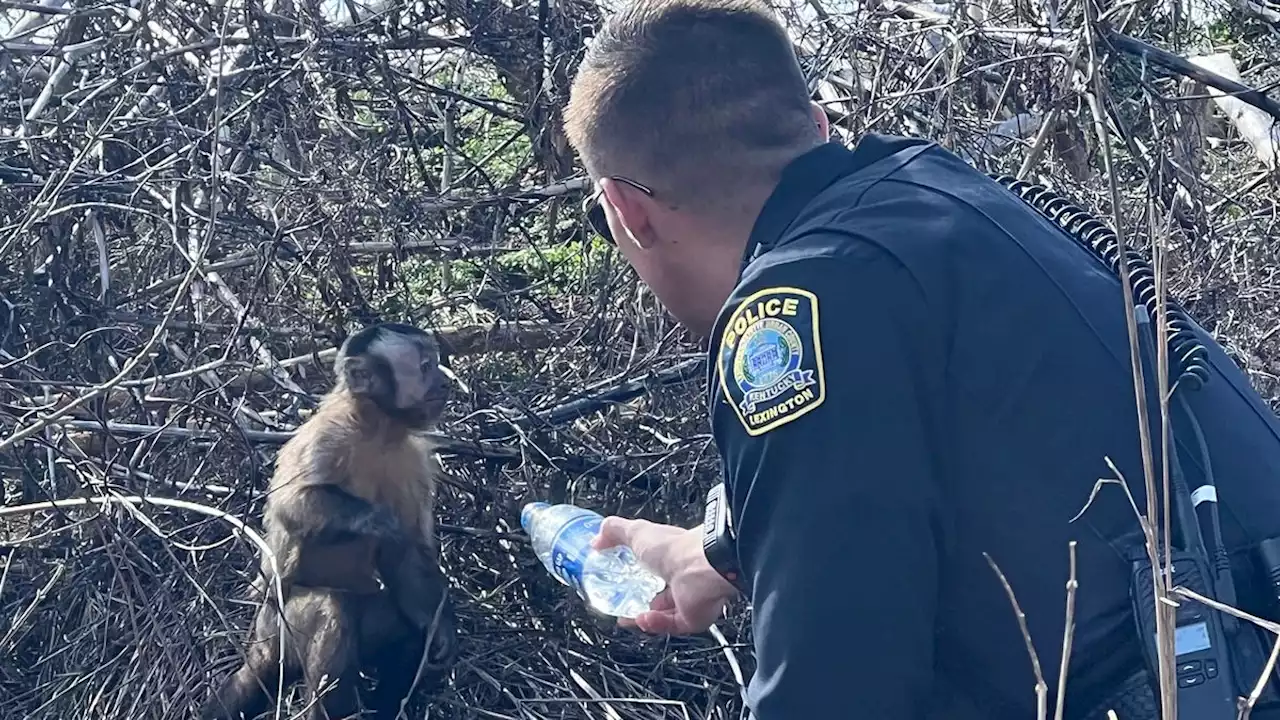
left=293, top=591, right=360, bottom=720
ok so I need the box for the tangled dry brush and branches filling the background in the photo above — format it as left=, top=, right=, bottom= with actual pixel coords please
left=0, top=0, right=1280, bottom=720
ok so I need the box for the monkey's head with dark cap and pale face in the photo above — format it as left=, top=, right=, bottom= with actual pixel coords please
left=339, top=323, right=451, bottom=429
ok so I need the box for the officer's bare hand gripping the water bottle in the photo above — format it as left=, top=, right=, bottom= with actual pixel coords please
left=593, top=516, right=737, bottom=635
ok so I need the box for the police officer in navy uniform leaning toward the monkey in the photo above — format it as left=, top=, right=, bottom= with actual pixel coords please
left=564, top=0, right=1280, bottom=720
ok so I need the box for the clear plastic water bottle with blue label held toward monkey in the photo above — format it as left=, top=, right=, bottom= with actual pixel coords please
left=520, top=502, right=667, bottom=618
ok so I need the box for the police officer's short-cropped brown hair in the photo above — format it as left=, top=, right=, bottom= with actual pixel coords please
left=564, top=0, right=820, bottom=206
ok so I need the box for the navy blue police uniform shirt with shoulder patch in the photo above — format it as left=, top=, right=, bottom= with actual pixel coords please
left=708, top=136, right=1280, bottom=720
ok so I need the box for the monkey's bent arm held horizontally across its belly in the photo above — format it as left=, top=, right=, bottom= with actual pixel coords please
left=273, top=483, right=404, bottom=543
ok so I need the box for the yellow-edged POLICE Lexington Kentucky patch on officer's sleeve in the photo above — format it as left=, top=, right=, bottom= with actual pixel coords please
left=717, top=287, right=827, bottom=437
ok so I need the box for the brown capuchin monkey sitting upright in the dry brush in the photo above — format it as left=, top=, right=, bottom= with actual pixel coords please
left=201, top=323, right=457, bottom=720
